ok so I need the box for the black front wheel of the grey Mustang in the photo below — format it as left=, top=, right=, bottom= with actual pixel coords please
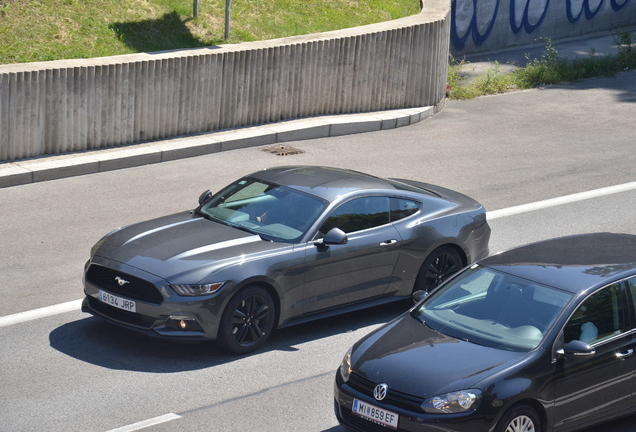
left=218, top=286, right=276, bottom=354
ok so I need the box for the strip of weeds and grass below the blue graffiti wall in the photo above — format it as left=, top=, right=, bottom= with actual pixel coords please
left=447, top=30, right=636, bottom=99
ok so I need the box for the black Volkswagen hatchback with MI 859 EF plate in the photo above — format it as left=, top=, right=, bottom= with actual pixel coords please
left=335, top=233, right=636, bottom=432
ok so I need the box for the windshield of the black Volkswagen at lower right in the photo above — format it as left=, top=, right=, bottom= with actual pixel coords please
left=411, top=265, right=572, bottom=351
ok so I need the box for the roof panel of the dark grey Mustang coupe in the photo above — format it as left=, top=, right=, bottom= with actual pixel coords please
left=249, top=166, right=410, bottom=201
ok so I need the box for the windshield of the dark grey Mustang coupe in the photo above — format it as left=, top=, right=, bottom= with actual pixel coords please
left=197, top=178, right=327, bottom=243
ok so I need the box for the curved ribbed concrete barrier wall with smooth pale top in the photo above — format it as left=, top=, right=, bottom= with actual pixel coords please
left=0, top=0, right=451, bottom=161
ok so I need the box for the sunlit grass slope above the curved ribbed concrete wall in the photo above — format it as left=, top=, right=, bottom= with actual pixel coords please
left=0, top=0, right=419, bottom=64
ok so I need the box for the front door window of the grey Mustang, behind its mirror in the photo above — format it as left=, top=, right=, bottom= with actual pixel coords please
left=319, top=197, right=390, bottom=237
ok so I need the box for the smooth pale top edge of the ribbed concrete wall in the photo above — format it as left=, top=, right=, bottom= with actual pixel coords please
left=0, top=0, right=451, bottom=74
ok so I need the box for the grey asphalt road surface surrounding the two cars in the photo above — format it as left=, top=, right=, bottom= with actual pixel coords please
left=0, top=72, right=636, bottom=432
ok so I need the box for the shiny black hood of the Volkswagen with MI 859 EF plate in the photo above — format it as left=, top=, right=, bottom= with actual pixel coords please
left=351, top=313, right=528, bottom=398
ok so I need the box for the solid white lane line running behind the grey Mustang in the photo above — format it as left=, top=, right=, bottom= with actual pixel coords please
left=0, top=182, right=636, bottom=327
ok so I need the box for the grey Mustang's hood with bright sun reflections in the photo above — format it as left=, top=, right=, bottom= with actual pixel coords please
left=95, top=212, right=291, bottom=283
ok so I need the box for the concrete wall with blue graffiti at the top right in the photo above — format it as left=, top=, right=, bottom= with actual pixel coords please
left=451, top=0, right=636, bottom=57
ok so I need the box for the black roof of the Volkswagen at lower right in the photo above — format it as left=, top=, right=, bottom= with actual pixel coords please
left=479, top=233, right=636, bottom=293
